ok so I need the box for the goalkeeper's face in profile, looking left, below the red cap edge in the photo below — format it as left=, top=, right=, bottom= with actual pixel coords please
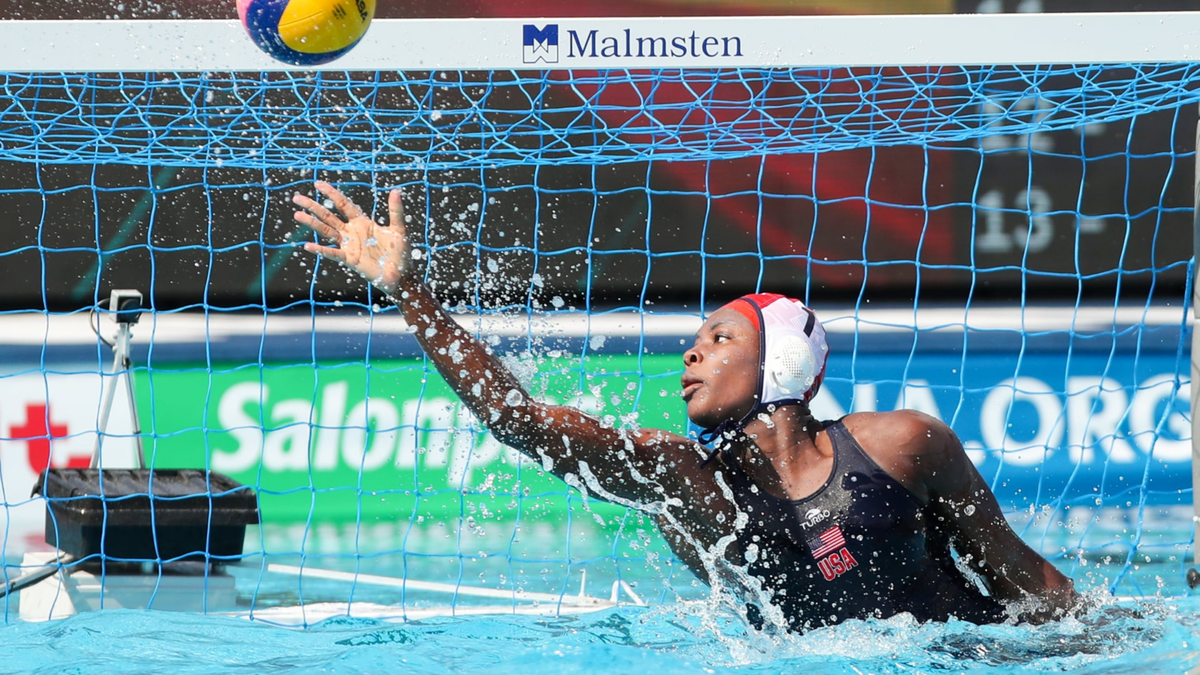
left=680, top=307, right=760, bottom=429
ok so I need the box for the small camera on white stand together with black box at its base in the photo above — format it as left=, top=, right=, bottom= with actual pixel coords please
left=28, top=283, right=260, bottom=578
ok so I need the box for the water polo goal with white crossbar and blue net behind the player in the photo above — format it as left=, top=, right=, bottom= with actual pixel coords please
left=0, top=13, right=1200, bottom=619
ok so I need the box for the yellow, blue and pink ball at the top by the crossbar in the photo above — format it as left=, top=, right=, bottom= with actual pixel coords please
left=238, top=0, right=376, bottom=66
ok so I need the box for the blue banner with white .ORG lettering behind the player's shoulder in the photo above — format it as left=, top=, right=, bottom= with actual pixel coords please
left=814, top=352, right=1192, bottom=508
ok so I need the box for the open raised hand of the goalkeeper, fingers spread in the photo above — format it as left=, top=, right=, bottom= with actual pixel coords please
left=292, top=180, right=412, bottom=295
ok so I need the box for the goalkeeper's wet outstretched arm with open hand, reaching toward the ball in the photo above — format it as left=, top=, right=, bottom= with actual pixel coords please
left=293, top=183, right=733, bottom=530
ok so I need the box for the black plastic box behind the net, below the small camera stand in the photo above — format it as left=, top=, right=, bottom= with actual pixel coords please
left=34, top=468, right=259, bottom=562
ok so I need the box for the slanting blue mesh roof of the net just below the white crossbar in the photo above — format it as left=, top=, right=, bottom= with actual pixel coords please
left=0, top=64, right=1198, bottom=171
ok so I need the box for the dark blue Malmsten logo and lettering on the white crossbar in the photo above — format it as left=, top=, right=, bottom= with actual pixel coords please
left=521, top=24, right=743, bottom=64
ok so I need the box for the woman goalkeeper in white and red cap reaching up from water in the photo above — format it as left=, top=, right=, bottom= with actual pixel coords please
left=294, top=181, right=1079, bottom=629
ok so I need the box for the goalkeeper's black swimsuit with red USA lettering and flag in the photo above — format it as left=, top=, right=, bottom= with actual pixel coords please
left=724, top=422, right=1004, bottom=631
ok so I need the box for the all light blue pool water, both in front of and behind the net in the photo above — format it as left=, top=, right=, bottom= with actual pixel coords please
left=0, top=516, right=1200, bottom=675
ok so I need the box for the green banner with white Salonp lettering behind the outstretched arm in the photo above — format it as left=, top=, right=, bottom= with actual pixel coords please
left=137, top=348, right=686, bottom=531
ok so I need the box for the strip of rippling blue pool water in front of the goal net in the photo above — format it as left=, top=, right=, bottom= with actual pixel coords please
left=0, top=597, right=1200, bottom=675
